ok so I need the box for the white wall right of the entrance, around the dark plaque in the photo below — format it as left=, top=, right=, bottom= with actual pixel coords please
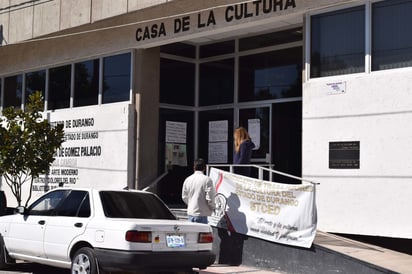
left=302, top=68, right=412, bottom=238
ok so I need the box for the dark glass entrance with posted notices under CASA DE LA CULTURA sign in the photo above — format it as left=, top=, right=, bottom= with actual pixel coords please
left=158, top=27, right=302, bottom=204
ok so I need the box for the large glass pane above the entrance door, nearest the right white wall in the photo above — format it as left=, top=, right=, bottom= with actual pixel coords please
left=239, top=47, right=302, bottom=102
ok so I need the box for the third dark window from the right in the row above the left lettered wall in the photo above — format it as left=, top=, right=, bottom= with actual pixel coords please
left=47, top=65, right=72, bottom=110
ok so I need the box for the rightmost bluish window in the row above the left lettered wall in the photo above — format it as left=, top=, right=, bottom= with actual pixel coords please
left=103, top=53, right=131, bottom=104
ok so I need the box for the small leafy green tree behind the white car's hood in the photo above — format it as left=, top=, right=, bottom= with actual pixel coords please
left=0, top=92, right=64, bottom=206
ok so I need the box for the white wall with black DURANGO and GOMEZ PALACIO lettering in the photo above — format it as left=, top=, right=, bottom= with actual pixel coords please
left=0, top=103, right=135, bottom=207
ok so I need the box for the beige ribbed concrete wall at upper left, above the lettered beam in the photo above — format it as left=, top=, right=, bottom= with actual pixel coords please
left=0, top=0, right=172, bottom=44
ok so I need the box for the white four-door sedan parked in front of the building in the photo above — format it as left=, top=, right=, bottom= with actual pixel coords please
left=0, top=188, right=215, bottom=274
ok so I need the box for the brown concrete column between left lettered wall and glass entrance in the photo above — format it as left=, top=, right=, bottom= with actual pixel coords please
left=133, top=47, right=160, bottom=189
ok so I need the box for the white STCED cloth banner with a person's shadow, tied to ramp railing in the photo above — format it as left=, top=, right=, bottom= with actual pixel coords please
left=209, top=168, right=317, bottom=248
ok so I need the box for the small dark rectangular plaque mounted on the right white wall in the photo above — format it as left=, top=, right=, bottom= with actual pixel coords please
left=329, top=141, right=360, bottom=169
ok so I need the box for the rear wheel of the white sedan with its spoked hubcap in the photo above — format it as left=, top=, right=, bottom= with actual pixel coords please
left=70, top=247, right=102, bottom=274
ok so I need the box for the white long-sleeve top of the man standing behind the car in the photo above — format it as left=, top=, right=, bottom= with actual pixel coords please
left=182, top=170, right=216, bottom=216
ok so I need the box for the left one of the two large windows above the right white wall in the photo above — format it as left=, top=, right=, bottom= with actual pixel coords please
left=310, top=6, right=365, bottom=78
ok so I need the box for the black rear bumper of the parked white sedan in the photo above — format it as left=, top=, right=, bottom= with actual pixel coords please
left=95, top=249, right=216, bottom=271
